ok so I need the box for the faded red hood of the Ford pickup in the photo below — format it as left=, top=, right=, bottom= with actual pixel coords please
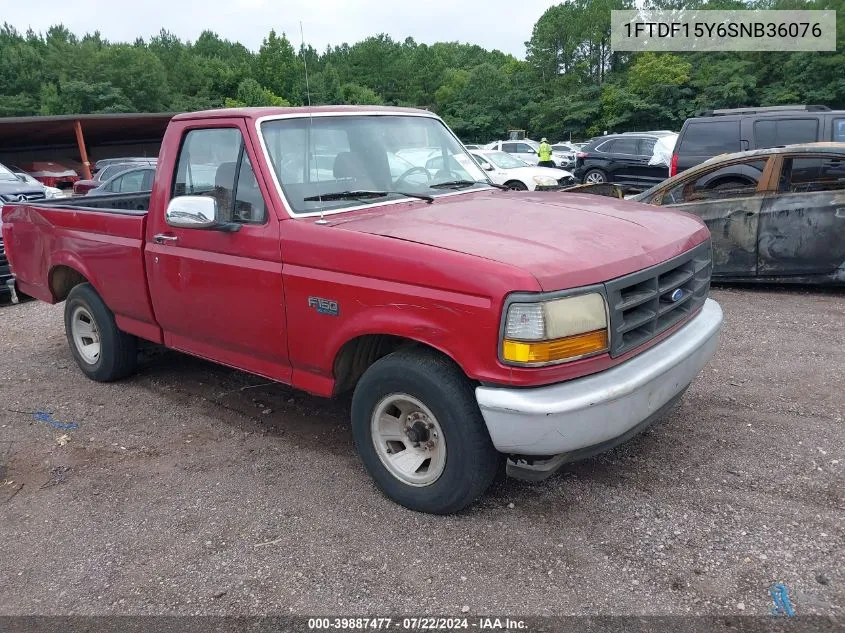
left=331, top=191, right=709, bottom=290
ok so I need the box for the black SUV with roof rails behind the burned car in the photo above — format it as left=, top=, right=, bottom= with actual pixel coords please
left=669, top=105, right=845, bottom=176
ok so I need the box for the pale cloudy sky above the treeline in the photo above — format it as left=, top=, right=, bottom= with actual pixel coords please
left=8, top=0, right=556, bottom=59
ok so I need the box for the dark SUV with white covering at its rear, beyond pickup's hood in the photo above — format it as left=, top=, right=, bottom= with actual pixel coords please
left=573, top=131, right=672, bottom=189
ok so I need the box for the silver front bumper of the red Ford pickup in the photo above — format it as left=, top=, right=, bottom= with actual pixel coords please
left=475, top=299, right=722, bottom=456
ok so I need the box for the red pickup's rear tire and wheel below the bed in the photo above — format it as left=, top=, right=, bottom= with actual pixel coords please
left=65, top=283, right=138, bottom=382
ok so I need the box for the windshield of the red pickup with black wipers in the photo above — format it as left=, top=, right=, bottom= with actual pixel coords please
left=261, top=115, right=490, bottom=214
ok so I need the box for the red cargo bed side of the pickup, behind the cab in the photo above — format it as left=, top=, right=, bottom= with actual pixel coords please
left=3, top=193, right=159, bottom=339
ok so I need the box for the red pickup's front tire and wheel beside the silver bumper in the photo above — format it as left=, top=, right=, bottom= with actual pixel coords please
left=352, top=349, right=503, bottom=514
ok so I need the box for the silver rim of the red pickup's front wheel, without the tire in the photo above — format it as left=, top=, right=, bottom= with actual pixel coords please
left=370, top=393, right=446, bottom=487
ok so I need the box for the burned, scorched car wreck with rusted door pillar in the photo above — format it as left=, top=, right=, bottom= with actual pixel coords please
left=629, top=143, right=845, bottom=285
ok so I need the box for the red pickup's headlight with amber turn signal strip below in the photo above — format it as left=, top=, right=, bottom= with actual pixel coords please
left=502, top=292, right=609, bottom=365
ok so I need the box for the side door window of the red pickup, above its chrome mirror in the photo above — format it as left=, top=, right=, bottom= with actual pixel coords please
left=173, top=128, right=267, bottom=224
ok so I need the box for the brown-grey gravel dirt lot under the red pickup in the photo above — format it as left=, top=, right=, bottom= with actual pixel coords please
left=0, top=288, right=845, bottom=616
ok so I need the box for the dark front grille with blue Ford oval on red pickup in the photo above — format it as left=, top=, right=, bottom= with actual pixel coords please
left=605, top=240, right=713, bottom=357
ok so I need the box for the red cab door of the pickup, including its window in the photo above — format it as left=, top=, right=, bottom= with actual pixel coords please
left=145, top=119, right=291, bottom=382
